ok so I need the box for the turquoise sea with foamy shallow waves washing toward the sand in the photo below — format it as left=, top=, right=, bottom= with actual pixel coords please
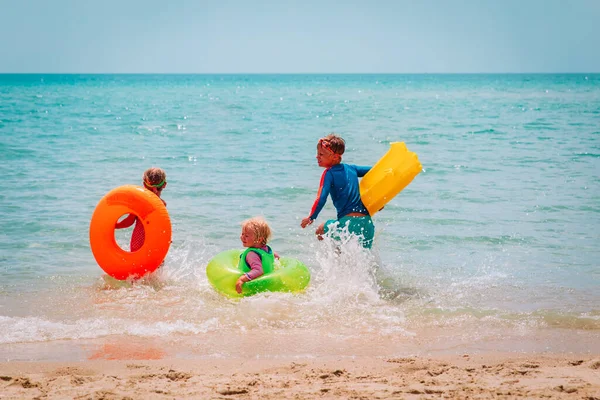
left=0, top=74, right=600, bottom=361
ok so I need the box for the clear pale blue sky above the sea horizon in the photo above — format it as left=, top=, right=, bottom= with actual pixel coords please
left=0, top=0, right=600, bottom=73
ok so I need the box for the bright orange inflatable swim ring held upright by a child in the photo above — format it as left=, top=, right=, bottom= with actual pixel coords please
left=90, top=185, right=171, bottom=280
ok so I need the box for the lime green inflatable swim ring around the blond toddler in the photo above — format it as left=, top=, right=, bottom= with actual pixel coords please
left=206, top=250, right=310, bottom=297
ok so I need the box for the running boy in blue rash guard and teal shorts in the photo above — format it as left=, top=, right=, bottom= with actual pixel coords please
left=300, top=133, right=375, bottom=248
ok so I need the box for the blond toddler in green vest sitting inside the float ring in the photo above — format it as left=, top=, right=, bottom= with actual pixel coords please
left=235, top=217, right=279, bottom=294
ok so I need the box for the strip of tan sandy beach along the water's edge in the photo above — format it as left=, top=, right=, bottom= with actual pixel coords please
left=0, top=354, right=600, bottom=400
